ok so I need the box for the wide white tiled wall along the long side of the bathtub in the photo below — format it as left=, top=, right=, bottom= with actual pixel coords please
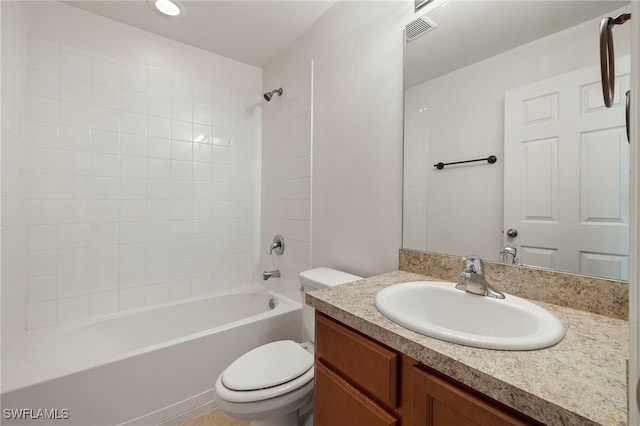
left=20, top=36, right=261, bottom=328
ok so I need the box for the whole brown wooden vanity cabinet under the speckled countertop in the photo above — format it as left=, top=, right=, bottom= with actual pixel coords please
left=313, top=312, right=540, bottom=426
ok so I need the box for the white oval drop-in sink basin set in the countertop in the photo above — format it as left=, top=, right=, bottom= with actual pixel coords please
left=376, top=281, right=564, bottom=350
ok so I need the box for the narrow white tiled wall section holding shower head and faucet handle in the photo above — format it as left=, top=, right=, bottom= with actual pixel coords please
left=260, top=66, right=313, bottom=300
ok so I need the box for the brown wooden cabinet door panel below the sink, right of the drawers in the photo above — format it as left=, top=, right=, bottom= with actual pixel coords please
left=412, top=368, right=539, bottom=426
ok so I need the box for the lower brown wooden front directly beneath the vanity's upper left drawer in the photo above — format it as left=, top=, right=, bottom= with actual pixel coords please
left=313, top=362, right=398, bottom=426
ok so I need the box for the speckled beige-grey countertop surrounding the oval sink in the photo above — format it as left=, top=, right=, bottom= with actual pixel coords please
left=306, top=271, right=629, bottom=426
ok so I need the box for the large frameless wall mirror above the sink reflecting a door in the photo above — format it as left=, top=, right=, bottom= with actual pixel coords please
left=403, top=0, right=630, bottom=280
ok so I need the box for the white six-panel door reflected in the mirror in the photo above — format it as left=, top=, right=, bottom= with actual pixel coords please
left=504, top=57, right=630, bottom=279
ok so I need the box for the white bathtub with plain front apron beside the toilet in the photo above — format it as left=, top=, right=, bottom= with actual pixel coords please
left=1, top=289, right=302, bottom=426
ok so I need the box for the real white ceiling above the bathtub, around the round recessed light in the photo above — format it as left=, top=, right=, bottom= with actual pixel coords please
left=64, top=0, right=337, bottom=68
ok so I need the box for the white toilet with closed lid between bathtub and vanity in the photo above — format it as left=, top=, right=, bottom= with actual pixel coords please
left=215, top=268, right=362, bottom=426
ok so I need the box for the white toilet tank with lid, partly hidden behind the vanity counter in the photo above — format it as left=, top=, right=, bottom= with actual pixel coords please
left=299, top=267, right=362, bottom=342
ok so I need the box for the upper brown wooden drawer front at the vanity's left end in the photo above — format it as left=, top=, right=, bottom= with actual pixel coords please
left=316, top=313, right=400, bottom=408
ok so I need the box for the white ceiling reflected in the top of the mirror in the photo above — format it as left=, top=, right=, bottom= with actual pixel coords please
left=405, top=0, right=629, bottom=88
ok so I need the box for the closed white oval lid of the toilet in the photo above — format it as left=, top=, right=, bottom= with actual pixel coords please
left=222, top=340, right=313, bottom=391
